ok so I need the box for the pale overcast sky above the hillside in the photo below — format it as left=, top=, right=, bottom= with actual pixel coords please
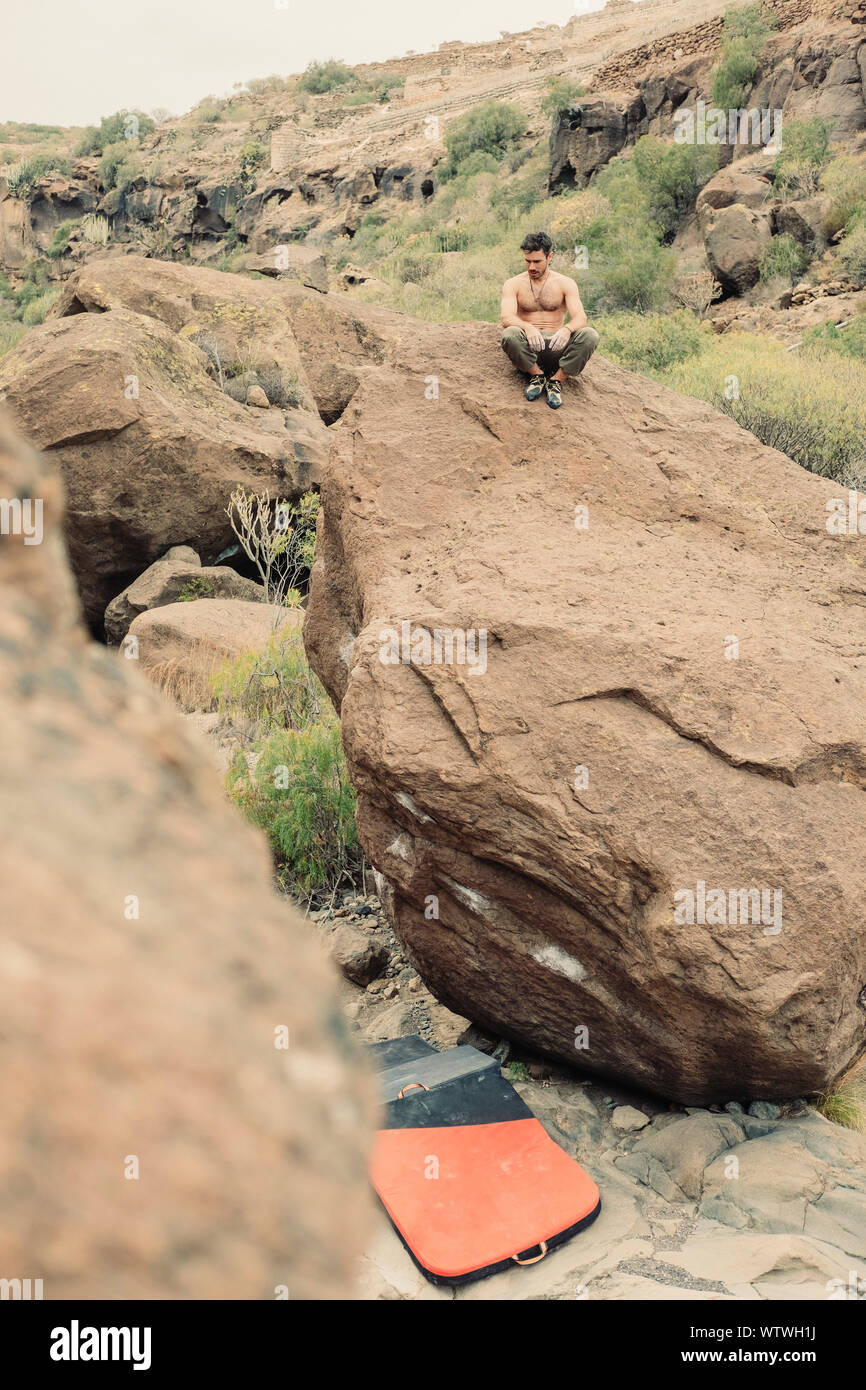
left=0, top=0, right=622, bottom=125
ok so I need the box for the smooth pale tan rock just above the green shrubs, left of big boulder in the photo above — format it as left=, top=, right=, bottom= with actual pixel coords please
left=124, top=599, right=303, bottom=710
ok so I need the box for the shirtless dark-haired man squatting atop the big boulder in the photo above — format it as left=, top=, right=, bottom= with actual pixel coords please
left=502, top=232, right=599, bottom=410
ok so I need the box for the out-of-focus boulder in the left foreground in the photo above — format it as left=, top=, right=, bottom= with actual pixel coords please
left=0, top=408, right=371, bottom=1302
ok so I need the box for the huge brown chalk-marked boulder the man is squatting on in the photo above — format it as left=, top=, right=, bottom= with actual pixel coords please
left=304, top=310, right=866, bottom=1104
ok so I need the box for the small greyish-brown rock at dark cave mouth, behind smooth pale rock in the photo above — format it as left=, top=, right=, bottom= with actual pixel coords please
left=104, top=545, right=265, bottom=646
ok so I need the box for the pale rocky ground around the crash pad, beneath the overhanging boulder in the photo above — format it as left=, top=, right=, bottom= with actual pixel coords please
left=323, top=894, right=866, bottom=1301
